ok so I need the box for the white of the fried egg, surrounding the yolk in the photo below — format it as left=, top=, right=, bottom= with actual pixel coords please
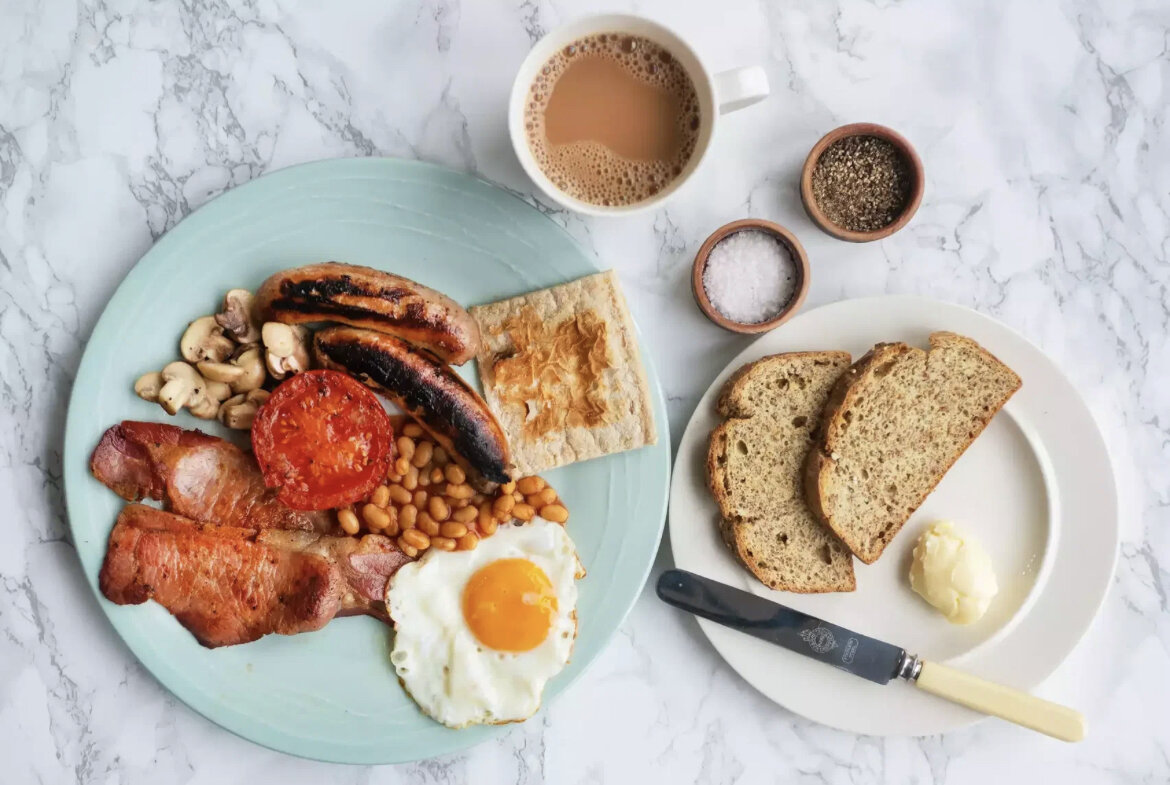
left=386, top=518, right=583, bottom=728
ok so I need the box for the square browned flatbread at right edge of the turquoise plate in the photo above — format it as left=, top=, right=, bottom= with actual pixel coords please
left=469, top=270, right=658, bottom=476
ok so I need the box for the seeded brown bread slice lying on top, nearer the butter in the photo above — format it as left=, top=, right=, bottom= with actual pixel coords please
left=805, top=332, right=1020, bottom=564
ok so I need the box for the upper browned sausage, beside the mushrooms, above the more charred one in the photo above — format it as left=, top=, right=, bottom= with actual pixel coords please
left=255, top=262, right=480, bottom=365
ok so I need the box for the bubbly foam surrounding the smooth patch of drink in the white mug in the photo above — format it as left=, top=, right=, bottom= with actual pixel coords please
left=524, top=33, right=701, bottom=206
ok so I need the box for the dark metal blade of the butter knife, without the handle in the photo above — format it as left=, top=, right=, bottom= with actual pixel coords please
left=658, top=570, right=906, bottom=684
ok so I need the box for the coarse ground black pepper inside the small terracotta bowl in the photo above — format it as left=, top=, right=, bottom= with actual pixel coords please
left=812, top=136, right=913, bottom=232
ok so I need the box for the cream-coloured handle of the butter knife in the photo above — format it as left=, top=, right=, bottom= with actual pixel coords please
left=915, top=662, right=1085, bottom=742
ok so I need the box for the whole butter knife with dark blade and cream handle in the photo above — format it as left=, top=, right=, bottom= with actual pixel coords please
left=658, top=570, right=1086, bottom=742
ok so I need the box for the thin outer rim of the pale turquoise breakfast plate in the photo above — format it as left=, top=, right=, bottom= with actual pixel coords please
left=61, top=156, right=674, bottom=765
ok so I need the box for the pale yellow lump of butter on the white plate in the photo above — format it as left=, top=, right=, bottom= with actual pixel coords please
left=910, top=521, right=999, bottom=625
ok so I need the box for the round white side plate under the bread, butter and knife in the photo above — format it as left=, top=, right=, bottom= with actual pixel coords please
left=669, top=296, right=1119, bottom=736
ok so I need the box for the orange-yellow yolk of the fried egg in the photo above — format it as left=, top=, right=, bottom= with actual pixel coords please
left=463, top=559, right=557, bottom=652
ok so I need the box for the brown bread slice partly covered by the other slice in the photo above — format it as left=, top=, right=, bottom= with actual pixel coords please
left=707, top=352, right=856, bottom=593
